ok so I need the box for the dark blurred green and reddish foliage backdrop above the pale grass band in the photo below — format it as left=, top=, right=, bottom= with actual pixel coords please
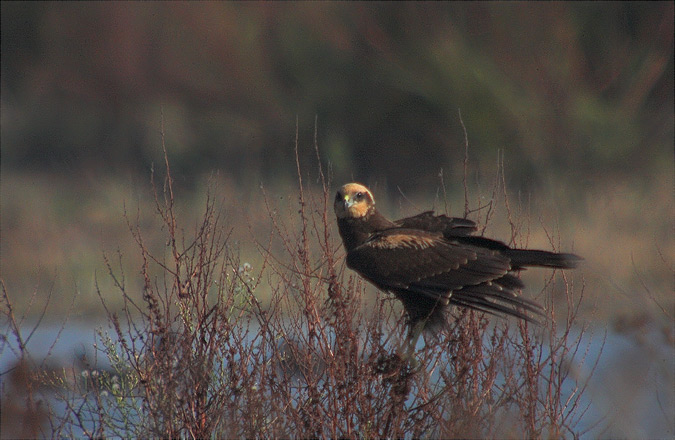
left=1, top=2, right=673, bottom=188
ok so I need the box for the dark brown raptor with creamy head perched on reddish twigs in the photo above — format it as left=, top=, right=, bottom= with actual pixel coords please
left=334, top=183, right=582, bottom=339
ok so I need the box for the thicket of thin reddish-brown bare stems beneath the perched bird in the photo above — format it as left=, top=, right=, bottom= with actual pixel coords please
left=4, top=136, right=593, bottom=438
